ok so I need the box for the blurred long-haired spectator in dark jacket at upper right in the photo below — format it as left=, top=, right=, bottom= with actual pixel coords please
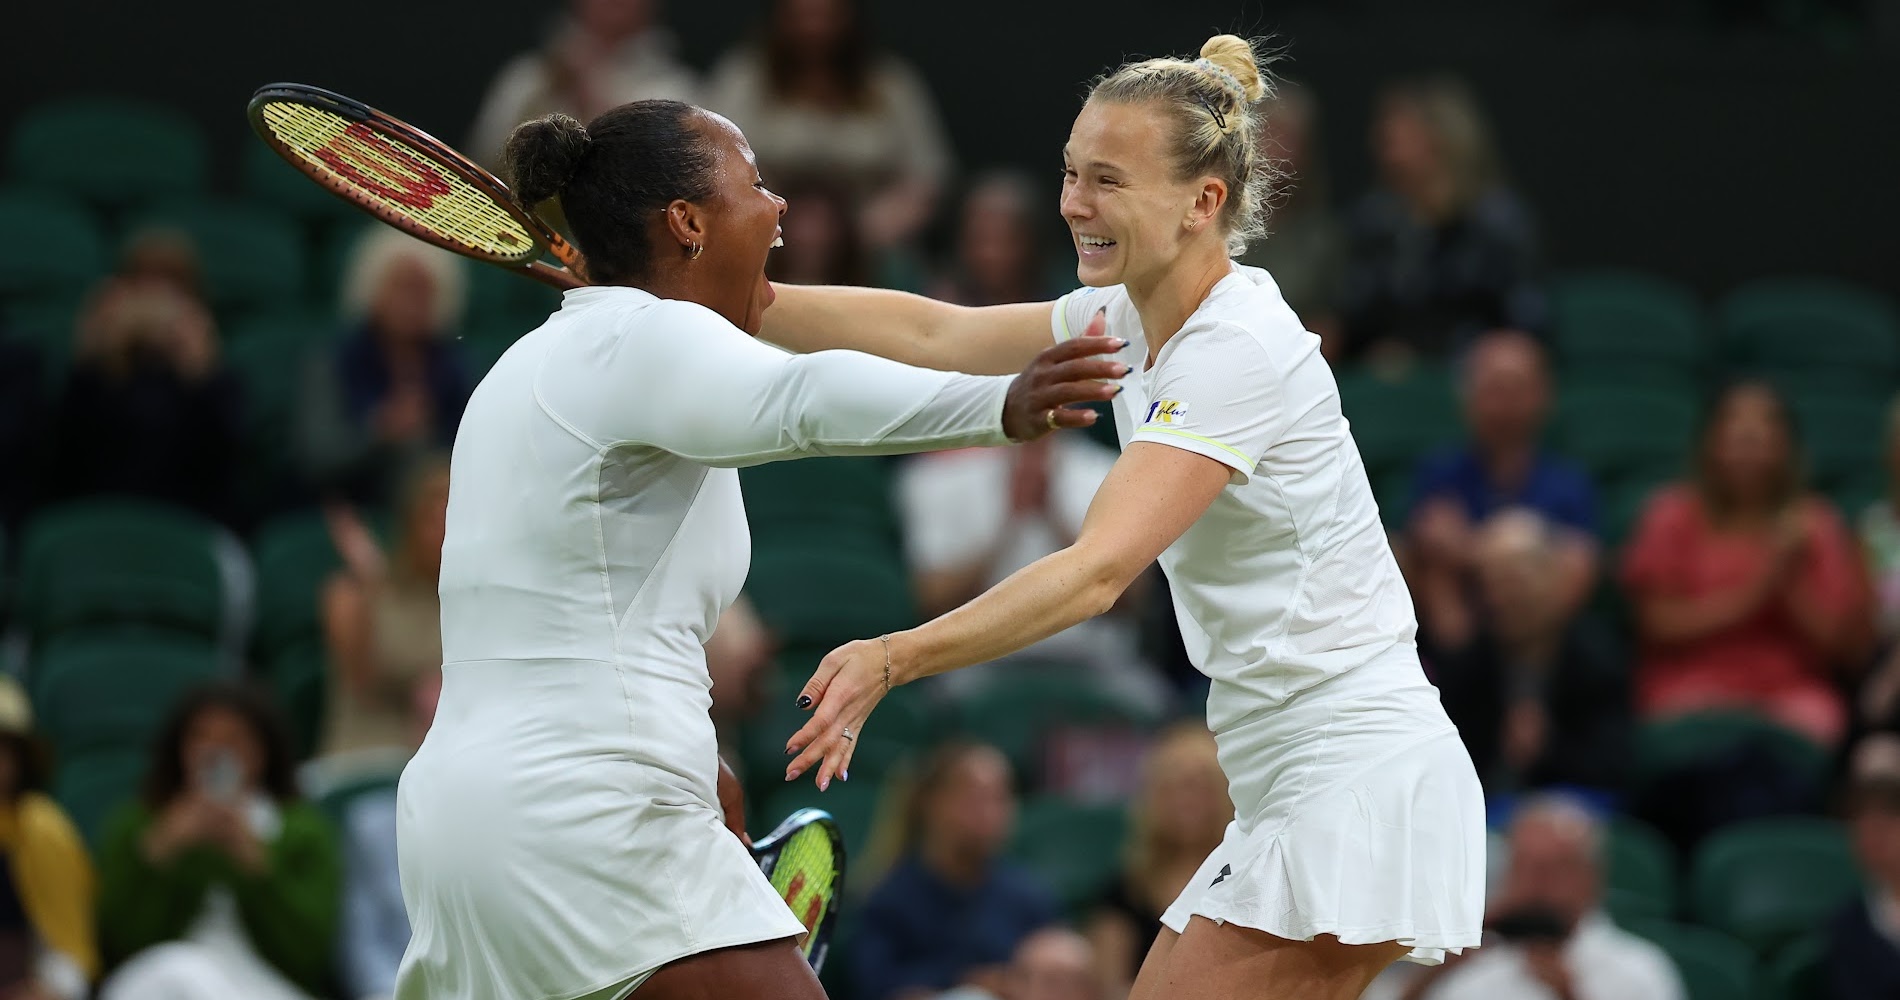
left=1343, top=78, right=1547, bottom=365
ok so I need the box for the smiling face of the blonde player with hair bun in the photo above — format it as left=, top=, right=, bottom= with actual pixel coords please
left=1062, top=101, right=1227, bottom=287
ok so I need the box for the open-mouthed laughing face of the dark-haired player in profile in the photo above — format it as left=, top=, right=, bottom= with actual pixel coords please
left=692, top=114, right=785, bottom=337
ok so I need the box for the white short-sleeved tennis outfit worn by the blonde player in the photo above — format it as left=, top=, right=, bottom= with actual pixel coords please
left=1053, top=264, right=1484, bottom=964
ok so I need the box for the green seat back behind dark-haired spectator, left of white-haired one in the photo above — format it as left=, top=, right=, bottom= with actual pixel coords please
left=133, top=200, right=304, bottom=314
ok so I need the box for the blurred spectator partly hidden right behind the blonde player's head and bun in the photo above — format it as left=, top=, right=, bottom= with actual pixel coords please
left=1241, top=84, right=1345, bottom=357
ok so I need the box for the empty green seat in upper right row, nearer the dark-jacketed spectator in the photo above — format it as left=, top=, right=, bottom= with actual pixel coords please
left=1550, top=272, right=1706, bottom=386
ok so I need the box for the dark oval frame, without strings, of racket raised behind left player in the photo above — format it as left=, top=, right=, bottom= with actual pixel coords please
left=245, top=84, right=587, bottom=289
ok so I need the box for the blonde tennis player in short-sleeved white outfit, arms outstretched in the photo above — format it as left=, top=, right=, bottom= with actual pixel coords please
left=764, top=36, right=1484, bottom=1000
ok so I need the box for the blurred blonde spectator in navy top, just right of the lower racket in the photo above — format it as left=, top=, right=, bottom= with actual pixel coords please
left=849, top=743, right=1056, bottom=1000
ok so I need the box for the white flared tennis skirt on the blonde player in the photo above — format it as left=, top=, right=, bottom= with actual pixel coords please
left=1161, top=648, right=1486, bottom=966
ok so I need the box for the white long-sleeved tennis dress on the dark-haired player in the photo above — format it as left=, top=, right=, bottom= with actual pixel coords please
left=395, top=287, right=1009, bottom=1000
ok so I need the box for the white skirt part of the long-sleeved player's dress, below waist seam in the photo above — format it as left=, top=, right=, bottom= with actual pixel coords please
left=395, top=660, right=804, bottom=1000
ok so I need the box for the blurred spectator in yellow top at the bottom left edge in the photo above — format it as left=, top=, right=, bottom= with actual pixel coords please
left=0, top=675, right=99, bottom=1000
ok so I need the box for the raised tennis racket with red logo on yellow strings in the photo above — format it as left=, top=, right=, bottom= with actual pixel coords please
left=249, top=84, right=585, bottom=289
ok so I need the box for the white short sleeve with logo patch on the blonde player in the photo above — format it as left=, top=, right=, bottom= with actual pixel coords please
left=1129, top=323, right=1286, bottom=485
